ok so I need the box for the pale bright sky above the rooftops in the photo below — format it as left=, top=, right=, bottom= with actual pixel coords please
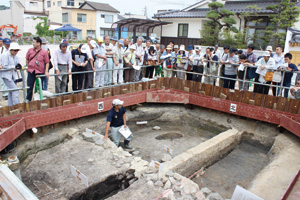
left=0, top=0, right=199, bottom=18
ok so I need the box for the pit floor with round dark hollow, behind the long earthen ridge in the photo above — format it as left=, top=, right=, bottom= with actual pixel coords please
left=120, top=116, right=227, bottom=162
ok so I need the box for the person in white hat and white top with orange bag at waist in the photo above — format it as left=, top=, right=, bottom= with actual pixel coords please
left=254, top=51, right=275, bottom=94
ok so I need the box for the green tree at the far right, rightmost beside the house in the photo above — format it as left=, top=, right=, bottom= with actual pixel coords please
left=265, top=0, right=300, bottom=47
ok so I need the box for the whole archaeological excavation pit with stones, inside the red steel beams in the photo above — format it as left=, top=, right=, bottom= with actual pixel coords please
left=2, top=104, right=299, bottom=200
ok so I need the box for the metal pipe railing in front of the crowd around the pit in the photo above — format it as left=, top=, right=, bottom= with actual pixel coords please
left=0, top=61, right=300, bottom=107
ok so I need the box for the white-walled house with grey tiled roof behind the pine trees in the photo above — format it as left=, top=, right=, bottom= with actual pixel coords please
left=153, top=0, right=300, bottom=48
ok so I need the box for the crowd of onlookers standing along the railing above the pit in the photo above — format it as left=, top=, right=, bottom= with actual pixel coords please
left=0, top=36, right=300, bottom=106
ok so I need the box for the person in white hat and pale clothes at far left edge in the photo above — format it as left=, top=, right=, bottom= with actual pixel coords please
left=0, top=42, right=22, bottom=106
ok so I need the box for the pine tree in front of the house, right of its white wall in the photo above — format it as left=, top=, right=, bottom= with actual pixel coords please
left=206, top=2, right=238, bottom=41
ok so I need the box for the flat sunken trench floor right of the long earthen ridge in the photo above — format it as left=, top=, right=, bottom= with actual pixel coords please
left=193, top=142, right=269, bottom=199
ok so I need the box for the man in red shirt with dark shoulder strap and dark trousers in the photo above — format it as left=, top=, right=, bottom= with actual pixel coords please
left=26, top=37, right=50, bottom=101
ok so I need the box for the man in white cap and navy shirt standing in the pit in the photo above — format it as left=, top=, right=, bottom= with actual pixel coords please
left=103, top=99, right=132, bottom=149
